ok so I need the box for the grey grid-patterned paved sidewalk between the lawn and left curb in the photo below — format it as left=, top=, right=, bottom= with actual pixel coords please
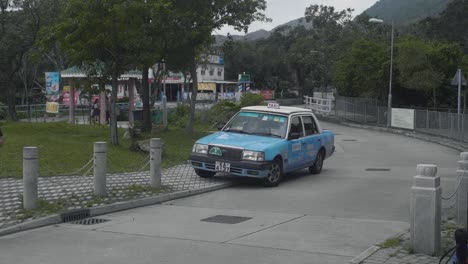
left=0, top=164, right=228, bottom=228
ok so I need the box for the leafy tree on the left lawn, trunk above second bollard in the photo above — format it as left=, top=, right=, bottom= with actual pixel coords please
left=46, top=0, right=148, bottom=145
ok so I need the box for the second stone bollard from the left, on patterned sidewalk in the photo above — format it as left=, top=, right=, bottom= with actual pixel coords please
left=94, top=142, right=107, bottom=196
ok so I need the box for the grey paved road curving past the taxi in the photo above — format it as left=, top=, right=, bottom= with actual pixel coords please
left=0, top=123, right=459, bottom=264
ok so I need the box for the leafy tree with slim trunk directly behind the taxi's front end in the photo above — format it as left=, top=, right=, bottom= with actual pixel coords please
left=166, top=0, right=266, bottom=133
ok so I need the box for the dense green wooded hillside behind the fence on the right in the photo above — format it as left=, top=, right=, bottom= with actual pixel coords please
left=223, top=0, right=468, bottom=108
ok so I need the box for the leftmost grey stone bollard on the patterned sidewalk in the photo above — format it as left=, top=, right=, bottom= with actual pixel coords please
left=23, top=147, right=39, bottom=209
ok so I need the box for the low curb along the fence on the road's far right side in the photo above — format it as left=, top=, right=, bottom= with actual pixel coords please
left=317, top=116, right=468, bottom=152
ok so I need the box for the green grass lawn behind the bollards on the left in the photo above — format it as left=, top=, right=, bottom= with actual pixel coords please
left=0, top=122, right=207, bottom=178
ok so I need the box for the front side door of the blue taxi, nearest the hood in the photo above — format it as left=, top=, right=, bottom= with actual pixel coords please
left=285, top=116, right=306, bottom=172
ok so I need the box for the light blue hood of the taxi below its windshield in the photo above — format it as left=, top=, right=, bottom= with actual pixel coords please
left=197, top=132, right=285, bottom=151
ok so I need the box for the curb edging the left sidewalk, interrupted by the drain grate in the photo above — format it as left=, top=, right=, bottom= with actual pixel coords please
left=0, top=182, right=234, bottom=237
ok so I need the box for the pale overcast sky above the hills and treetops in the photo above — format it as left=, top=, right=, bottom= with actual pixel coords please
left=215, top=0, right=377, bottom=35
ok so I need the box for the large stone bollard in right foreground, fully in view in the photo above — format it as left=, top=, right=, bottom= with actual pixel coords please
left=410, top=164, right=442, bottom=255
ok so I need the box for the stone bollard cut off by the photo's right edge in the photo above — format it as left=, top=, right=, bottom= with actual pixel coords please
left=457, top=152, right=468, bottom=227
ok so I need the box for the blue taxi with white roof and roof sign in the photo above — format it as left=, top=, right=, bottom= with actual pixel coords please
left=189, top=103, right=335, bottom=186
